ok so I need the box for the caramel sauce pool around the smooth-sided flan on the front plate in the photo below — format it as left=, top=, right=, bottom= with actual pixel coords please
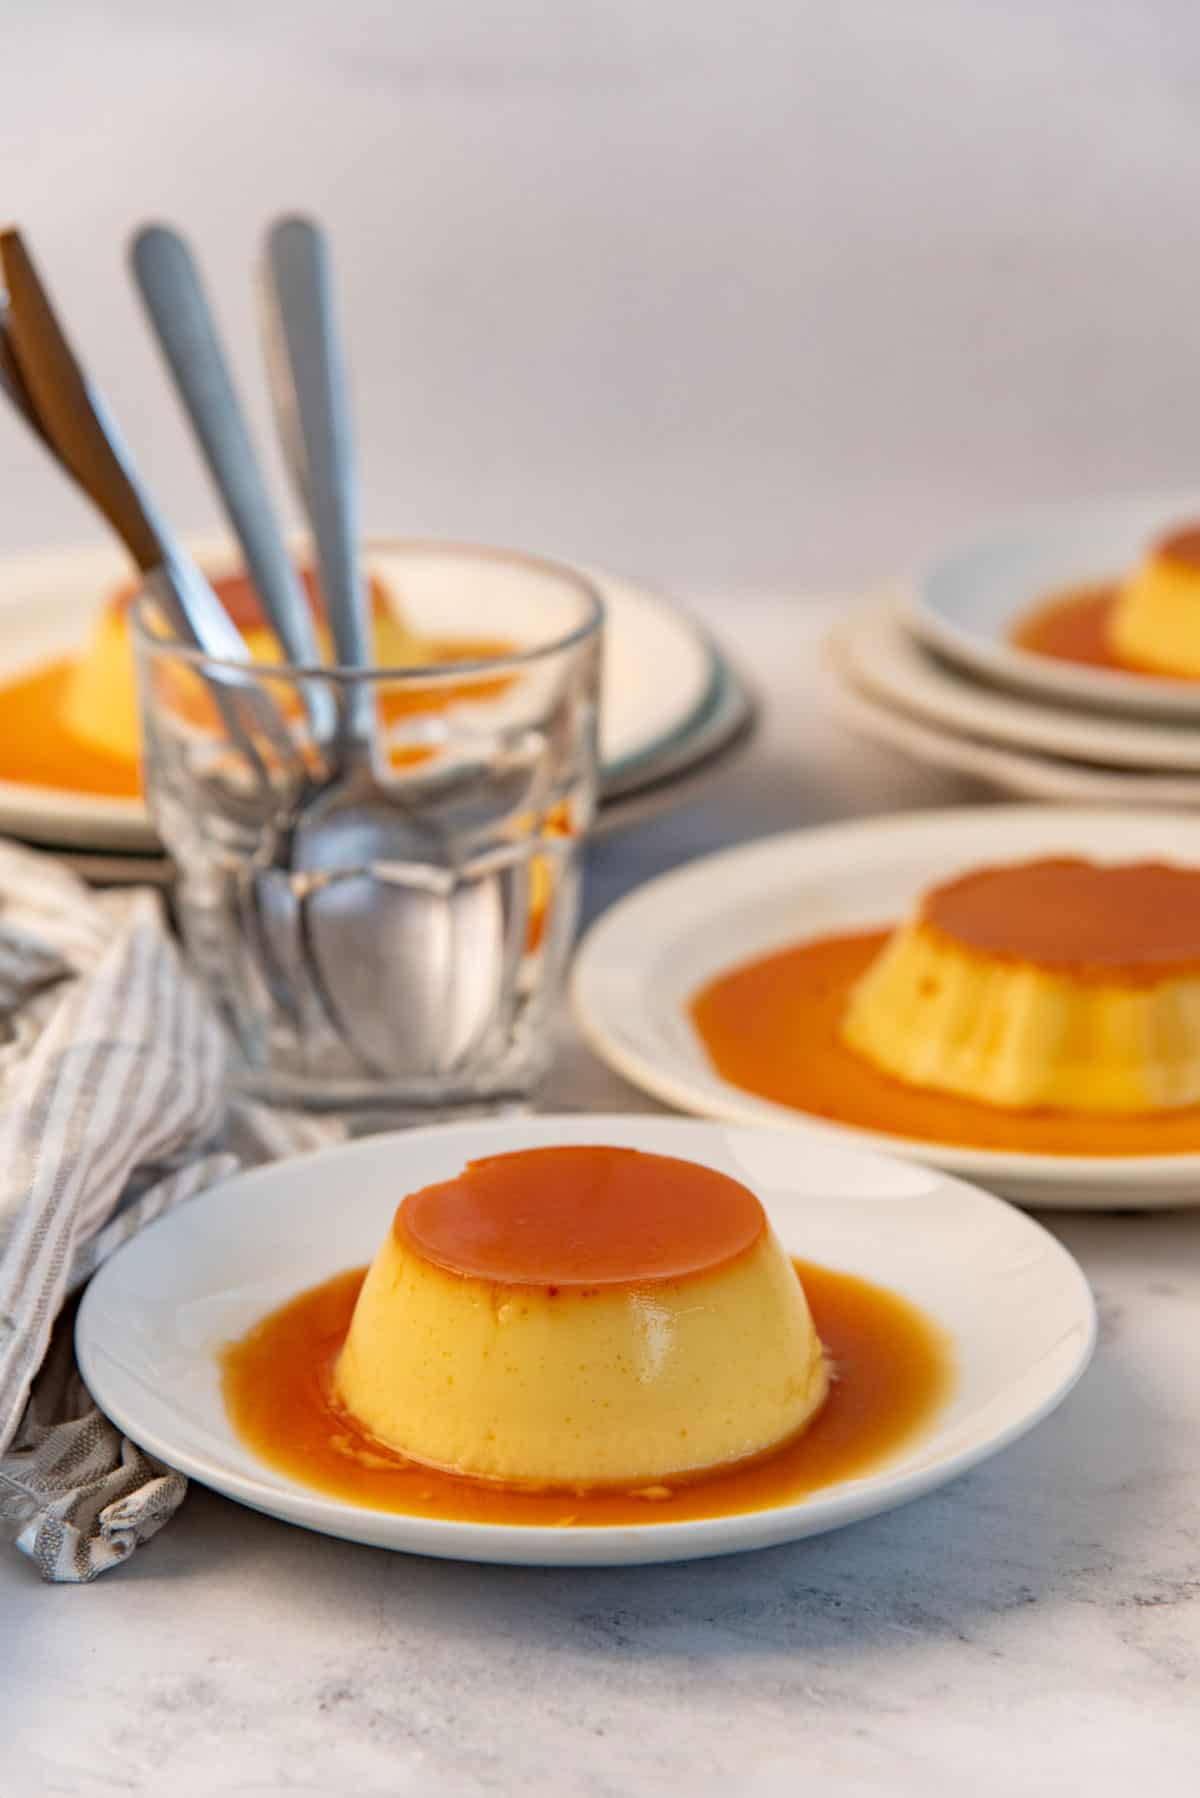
left=221, top=1260, right=954, bottom=1525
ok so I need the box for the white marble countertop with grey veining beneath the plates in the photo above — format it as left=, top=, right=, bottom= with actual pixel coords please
left=0, top=599, right=1200, bottom=1798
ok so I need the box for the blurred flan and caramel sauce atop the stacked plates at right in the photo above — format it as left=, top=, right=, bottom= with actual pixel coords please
left=1013, top=523, right=1200, bottom=680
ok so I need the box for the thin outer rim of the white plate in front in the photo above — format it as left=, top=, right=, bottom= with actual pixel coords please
left=74, top=1111, right=1097, bottom=1568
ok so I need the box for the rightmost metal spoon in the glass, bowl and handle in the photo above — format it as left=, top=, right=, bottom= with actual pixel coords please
left=264, top=218, right=504, bottom=1077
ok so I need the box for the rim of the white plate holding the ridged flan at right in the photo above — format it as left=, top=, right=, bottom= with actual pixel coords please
left=569, top=802, right=1200, bottom=1210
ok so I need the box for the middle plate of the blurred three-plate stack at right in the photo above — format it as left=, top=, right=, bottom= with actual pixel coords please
left=835, top=593, right=1200, bottom=773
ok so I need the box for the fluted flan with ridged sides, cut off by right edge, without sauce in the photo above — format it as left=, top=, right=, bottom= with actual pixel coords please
left=840, top=858, right=1200, bottom=1113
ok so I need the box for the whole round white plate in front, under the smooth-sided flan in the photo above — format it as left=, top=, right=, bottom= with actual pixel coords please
left=76, top=1117, right=1096, bottom=1566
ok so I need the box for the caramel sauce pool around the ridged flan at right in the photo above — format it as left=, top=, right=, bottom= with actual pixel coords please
left=691, top=930, right=1200, bottom=1154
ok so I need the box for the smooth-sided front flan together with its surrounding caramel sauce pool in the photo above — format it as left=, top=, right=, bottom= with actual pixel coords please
left=223, top=1145, right=950, bottom=1523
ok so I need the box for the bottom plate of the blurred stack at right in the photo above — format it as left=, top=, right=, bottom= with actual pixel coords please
left=828, top=640, right=1200, bottom=806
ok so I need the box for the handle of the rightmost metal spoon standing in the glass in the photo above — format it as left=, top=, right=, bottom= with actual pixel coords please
left=266, top=218, right=372, bottom=734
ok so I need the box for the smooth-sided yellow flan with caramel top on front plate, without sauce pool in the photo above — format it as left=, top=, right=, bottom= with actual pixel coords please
left=333, top=1145, right=828, bottom=1496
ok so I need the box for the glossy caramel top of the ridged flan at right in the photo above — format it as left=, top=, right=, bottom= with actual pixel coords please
left=919, top=856, right=1200, bottom=987
